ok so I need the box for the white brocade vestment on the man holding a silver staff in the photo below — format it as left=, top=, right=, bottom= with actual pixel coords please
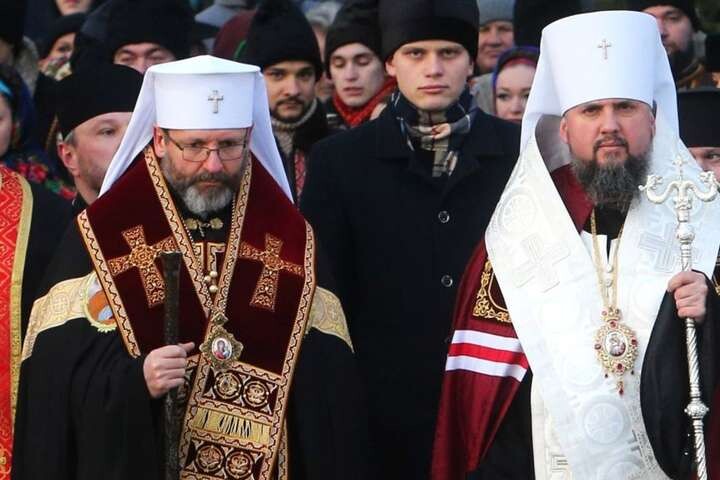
left=485, top=117, right=720, bottom=480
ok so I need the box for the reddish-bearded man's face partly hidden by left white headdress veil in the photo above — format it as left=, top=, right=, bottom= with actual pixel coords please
left=58, top=112, right=132, bottom=203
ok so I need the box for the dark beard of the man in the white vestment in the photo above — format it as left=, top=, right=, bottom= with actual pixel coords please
left=571, top=150, right=650, bottom=212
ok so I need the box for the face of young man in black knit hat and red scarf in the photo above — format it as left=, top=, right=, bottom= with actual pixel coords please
left=330, top=43, right=385, bottom=107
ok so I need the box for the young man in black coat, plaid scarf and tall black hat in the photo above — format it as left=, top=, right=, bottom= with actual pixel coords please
left=301, top=0, right=519, bottom=479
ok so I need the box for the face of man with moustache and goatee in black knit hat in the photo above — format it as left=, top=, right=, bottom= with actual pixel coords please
left=263, top=60, right=316, bottom=122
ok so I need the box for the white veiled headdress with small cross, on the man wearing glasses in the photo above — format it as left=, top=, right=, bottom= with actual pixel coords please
left=100, top=55, right=292, bottom=201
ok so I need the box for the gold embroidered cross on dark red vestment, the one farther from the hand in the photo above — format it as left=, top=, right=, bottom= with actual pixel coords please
left=240, top=234, right=303, bottom=312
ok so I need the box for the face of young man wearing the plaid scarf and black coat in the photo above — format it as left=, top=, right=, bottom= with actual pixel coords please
left=385, top=40, right=473, bottom=112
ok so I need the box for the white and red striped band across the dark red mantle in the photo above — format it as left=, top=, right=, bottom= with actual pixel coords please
left=445, top=330, right=528, bottom=382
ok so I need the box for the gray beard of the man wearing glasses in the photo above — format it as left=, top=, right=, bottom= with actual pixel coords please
left=160, top=157, right=244, bottom=219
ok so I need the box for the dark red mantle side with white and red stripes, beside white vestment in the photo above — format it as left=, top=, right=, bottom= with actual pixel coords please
left=431, top=243, right=529, bottom=480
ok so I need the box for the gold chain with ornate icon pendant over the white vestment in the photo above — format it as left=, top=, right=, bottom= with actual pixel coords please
left=590, top=209, right=638, bottom=395
